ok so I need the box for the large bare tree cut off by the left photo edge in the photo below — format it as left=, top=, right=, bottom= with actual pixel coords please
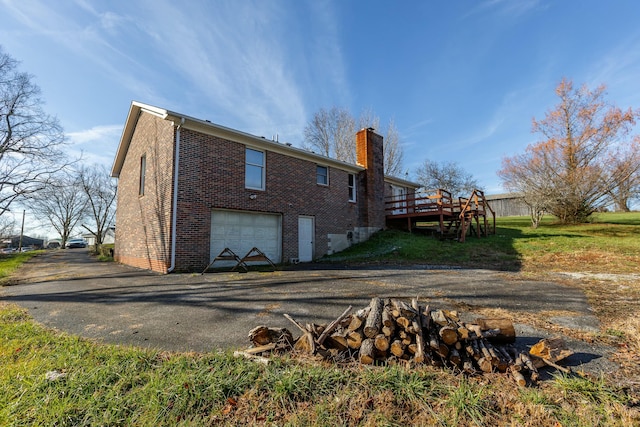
left=0, top=47, right=67, bottom=216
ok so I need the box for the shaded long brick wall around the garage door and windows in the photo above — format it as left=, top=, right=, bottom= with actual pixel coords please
left=171, top=129, right=358, bottom=271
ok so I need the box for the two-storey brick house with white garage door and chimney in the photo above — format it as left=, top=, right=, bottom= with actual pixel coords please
left=111, top=102, right=418, bottom=273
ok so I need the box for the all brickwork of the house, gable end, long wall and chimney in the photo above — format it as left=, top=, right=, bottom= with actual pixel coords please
left=115, top=113, right=384, bottom=272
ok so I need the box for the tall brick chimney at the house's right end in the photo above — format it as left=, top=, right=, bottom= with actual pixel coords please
left=356, top=128, right=385, bottom=229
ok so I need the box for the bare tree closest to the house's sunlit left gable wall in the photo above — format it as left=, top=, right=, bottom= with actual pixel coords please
left=79, top=165, right=118, bottom=252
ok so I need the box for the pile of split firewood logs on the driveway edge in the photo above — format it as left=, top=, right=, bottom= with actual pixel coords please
left=236, top=297, right=572, bottom=385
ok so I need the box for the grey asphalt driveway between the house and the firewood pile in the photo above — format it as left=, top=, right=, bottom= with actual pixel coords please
left=0, top=249, right=606, bottom=374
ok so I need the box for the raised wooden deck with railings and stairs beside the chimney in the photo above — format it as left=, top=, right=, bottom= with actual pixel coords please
left=385, top=189, right=496, bottom=242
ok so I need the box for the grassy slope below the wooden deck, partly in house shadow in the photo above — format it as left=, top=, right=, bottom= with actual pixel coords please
left=324, top=212, right=640, bottom=273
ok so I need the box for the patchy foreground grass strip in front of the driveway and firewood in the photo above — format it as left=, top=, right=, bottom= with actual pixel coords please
left=0, top=304, right=640, bottom=426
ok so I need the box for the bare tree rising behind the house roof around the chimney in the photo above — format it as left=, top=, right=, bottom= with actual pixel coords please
left=303, top=107, right=403, bottom=176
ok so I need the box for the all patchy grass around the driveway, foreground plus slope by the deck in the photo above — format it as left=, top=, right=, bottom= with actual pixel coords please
left=0, top=213, right=640, bottom=426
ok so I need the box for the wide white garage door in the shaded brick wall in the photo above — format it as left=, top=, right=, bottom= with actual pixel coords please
left=210, top=210, right=282, bottom=266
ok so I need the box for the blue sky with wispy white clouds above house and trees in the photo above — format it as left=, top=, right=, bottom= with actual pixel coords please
left=0, top=0, right=640, bottom=236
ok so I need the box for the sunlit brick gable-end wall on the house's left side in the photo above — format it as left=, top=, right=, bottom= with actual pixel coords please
left=114, top=113, right=174, bottom=272
